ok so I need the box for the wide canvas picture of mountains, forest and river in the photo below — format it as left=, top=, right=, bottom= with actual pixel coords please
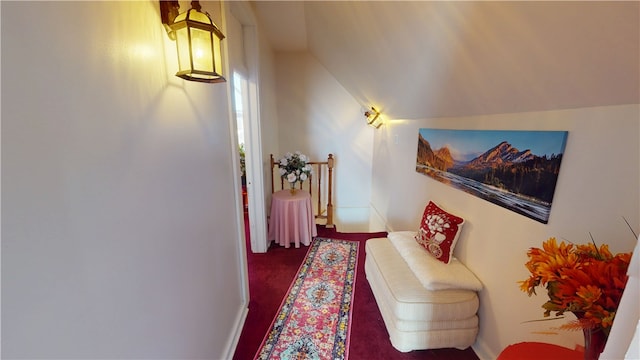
left=416, top=129, right=568, bottom=224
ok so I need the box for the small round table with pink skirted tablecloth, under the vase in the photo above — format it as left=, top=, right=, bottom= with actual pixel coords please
left=269, top=189, right=318, bottom=248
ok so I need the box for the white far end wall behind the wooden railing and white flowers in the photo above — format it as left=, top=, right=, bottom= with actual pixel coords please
left=274, top=52, right=375, bottom=231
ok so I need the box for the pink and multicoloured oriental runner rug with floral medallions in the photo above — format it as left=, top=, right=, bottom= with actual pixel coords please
left=255, top=238, right=358, bottom=360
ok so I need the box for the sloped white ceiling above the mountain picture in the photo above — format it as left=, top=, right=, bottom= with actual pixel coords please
left=256, top=1, right=640, bottom=119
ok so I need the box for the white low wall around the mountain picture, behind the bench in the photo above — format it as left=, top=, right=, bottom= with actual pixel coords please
left=372, top=105, right=640, bottom=359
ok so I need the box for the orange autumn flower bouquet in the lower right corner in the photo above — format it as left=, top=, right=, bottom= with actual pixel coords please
left=519, top=238, right=631, bottom=335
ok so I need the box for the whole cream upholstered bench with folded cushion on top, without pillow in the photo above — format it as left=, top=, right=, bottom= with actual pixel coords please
left=365, top=231, right=482, bottom=352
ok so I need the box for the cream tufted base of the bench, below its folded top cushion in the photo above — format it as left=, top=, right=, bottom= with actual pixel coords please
left=364, top=238, right=479, bottom=352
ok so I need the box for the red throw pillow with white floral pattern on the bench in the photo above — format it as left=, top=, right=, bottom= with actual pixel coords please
left=416, top=201, right=464, bottom=264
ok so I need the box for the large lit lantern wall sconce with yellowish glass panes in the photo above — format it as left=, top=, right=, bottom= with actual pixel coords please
left=160, top=0, right=226, bottom=83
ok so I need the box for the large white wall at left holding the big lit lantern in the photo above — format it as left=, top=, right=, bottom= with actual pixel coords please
left=1, top=1, right=245, bottom=359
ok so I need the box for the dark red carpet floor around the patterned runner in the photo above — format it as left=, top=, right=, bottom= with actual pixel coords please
left=233, top=215, right=478, bottom=360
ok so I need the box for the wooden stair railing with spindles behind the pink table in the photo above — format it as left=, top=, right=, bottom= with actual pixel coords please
left=269, top=154, right=334, bottom=228
